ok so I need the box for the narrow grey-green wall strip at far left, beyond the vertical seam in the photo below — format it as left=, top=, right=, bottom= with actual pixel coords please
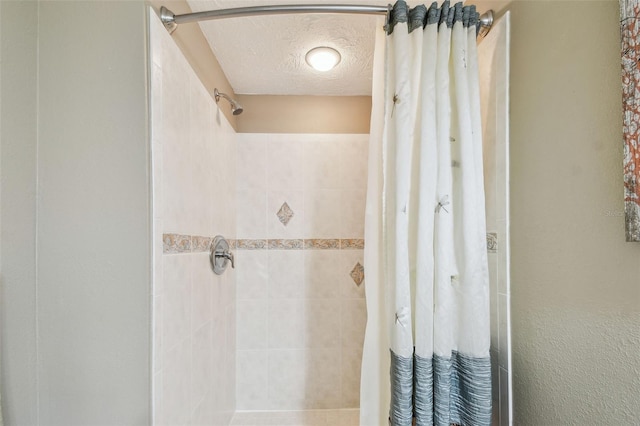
left=0, top=1, right=38, bottom=424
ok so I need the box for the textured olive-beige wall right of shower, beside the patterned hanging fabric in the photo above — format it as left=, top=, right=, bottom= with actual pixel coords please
left=509, top=0, right=640, bottom=425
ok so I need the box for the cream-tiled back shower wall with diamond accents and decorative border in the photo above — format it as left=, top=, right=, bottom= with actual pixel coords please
left=236, top=134, right=368, bottom=410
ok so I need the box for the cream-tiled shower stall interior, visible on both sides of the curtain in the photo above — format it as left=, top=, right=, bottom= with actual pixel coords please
left=149, top=2, right=510, bottom=425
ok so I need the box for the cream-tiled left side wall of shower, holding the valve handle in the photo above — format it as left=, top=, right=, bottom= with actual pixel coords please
left=150, top=13, right=236, bottom=425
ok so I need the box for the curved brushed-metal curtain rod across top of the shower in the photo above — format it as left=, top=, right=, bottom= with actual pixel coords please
left=160, top=4, right=493, bottom=38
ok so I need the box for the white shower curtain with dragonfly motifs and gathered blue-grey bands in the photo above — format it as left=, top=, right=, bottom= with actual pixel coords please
left=360, top=1, right=491, bottom=426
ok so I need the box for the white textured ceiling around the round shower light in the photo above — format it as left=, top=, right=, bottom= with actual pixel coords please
left=188, top=0, right=388, bottom=96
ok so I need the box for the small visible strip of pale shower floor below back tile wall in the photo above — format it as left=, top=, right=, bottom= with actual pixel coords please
left=231, top=408, right=360, bottom=426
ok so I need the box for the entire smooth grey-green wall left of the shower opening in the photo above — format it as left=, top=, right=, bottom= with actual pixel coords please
left=0, top=1, right=151, bottom=425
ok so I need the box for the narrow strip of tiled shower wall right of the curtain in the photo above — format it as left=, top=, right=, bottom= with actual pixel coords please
left=478, top=13, right=511, bottom=425
